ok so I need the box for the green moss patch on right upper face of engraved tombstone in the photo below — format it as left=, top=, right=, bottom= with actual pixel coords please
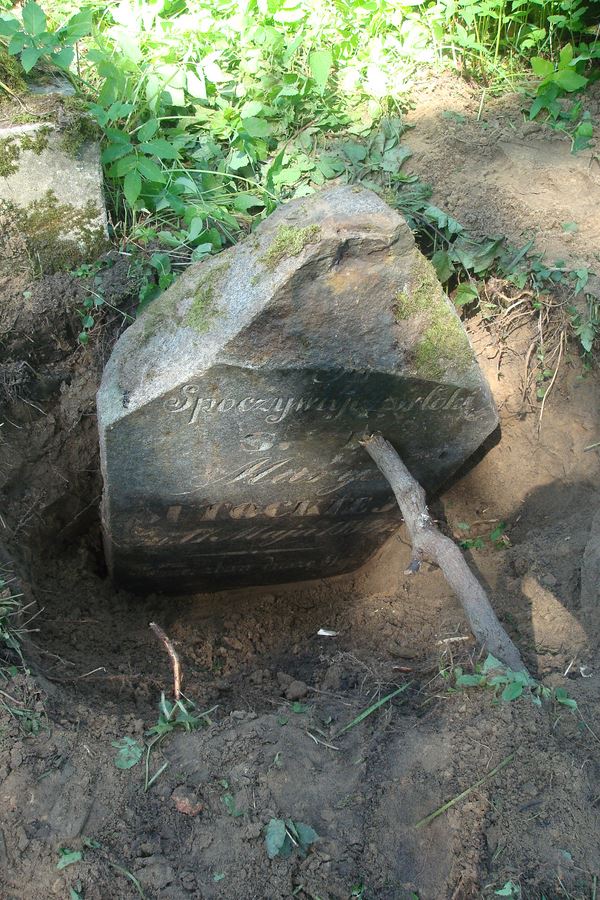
left=394, top=253, right=473, bottom=379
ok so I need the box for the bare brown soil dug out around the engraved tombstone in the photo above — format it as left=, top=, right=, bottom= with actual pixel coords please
left=0, top=72, right=600, bottom=900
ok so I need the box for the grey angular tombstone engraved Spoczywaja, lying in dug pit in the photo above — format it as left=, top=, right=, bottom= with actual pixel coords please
left=98, top=186, right=497, bottom=592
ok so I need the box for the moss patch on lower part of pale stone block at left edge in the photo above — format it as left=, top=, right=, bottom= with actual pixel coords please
left=16, top=191, right=107, bottom=275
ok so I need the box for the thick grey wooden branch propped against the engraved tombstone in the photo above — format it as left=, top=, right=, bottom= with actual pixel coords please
left=363, top=434, right=527, bottom=672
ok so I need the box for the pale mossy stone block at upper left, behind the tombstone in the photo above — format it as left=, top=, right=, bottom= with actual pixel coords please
left=0, top=119, right=107, bottom=273
